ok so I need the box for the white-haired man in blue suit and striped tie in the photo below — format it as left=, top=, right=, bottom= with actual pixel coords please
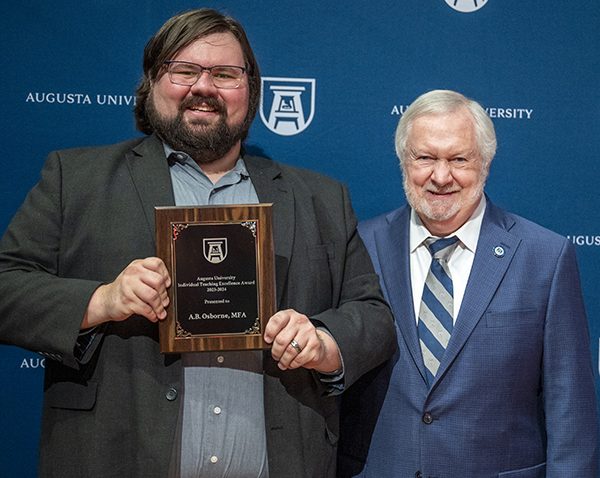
left=338, top=90, right=598, bottom=478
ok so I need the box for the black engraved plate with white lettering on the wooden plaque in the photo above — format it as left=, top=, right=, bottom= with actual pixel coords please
left=173, top=221, right=258, bottom=336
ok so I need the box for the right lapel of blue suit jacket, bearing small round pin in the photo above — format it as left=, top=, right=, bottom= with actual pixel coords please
left=432, top=200, right=521, bottom=388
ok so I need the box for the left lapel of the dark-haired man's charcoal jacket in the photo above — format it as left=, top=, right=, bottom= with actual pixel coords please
left=125, top=136, right=175, bottom=242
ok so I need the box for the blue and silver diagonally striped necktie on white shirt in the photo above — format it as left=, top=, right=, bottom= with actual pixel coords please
left=418, top=236, right=458, bottom=385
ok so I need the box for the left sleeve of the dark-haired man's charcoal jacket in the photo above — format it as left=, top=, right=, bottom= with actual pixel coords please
left=0, top=152, right=100, bottom=366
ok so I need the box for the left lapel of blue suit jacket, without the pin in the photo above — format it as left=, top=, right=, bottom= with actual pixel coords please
left=375, top=207, right=426, bottom=382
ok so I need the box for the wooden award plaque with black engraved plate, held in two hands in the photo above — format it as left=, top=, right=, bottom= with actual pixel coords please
left=155, top=204, right=275, bottom=353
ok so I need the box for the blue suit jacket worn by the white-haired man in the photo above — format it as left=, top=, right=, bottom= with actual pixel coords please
left=338, top=200, right=598, bottom=478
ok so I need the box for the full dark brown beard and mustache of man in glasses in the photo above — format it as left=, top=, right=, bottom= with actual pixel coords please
left=146, top=95, right=248, bottom=164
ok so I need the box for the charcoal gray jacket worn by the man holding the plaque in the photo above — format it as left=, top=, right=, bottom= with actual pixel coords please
left=0, top=136, right=395, bottom=478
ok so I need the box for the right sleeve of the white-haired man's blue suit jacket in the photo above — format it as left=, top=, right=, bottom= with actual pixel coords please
left=542, top=240, right=598, bottom=478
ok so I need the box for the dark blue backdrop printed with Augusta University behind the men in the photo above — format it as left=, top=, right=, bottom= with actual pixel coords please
left=0, top=0, right=600, bottom=477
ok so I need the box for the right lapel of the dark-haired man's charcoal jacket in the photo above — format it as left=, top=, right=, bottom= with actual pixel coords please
left=244, top=156, right=296, bottom=303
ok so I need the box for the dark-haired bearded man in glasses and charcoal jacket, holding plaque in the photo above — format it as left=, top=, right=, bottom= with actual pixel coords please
left=0, top=9, right=395, bottom=478
